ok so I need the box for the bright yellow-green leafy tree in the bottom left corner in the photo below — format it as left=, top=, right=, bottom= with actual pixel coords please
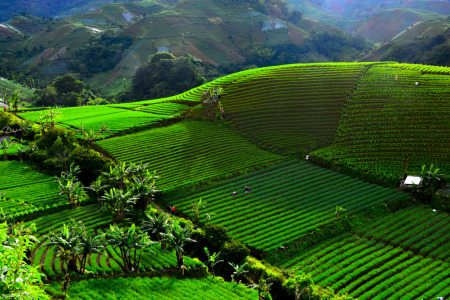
left=0, top=222, right=49, bottom=299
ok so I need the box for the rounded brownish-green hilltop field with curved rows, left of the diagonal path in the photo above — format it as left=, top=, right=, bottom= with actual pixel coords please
left=221, top=64, right=374, bottom=152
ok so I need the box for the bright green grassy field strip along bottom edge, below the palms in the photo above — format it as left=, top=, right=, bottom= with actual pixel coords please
left=47, top=277, right=258, bottom=300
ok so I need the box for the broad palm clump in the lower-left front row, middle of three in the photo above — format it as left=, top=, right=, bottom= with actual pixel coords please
left=105, top=224, right=155, bottom=272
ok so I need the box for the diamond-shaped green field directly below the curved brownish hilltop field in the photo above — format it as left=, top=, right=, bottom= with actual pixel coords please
left=97, top=122, right=286, bottom=190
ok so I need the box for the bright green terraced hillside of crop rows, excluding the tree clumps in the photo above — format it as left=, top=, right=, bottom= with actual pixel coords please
left=0, top=62, right=450, bottom=300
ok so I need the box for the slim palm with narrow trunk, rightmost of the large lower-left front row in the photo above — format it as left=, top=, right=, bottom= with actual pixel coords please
left=161, top=220, right=195, bottom=269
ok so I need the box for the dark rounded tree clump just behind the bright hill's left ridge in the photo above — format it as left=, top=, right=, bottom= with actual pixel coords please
left=132, top=54, right=205, bottom=100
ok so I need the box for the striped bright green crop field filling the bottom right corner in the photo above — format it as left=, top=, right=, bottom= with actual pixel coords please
left=280, top=207, right=450, bottom=299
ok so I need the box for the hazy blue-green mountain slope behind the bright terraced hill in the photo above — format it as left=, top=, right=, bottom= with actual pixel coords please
left=0, top=0, right=372, bottom=95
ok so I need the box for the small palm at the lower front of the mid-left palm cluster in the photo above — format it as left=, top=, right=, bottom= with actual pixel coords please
left=100, top=188, right=138, bottom=223
